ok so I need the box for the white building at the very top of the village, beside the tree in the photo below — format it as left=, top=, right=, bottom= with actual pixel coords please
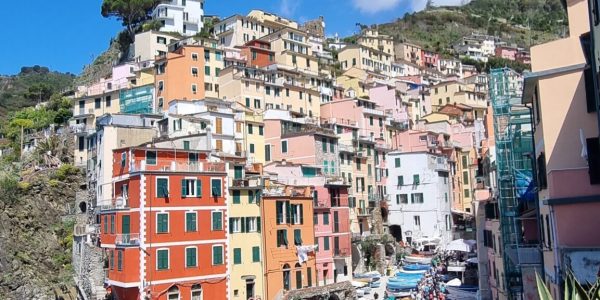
left=152, top=0, right=204, bottom=36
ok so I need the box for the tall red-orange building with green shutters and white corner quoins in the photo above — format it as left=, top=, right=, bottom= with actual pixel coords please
left=100, top=146, right=228, bottom=300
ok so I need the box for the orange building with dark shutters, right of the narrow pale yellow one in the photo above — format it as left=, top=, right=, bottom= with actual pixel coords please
left=261, top=186, right=317, bottom=300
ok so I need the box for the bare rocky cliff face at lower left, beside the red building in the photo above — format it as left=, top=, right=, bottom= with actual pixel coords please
left=0, top=169, right=85, bottom=299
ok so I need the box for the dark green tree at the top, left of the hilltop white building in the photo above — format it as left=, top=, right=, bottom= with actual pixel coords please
left=102, top=0, right=158, bottom=40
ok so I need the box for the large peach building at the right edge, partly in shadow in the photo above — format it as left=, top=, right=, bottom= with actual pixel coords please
left=523, top=0, right=600, bottom=299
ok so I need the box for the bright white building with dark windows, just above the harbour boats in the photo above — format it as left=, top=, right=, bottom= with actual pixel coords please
left=386, top=152, right=452, bottom=244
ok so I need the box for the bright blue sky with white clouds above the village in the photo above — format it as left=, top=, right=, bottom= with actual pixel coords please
left=0, top=0, right=461, bottom=75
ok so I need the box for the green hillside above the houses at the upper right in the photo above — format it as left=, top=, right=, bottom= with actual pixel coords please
left=378, top=0, right=568, bottom=56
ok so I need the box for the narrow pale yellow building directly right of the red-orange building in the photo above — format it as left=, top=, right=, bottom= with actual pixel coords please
left=226, top=158, right=265, bottom=300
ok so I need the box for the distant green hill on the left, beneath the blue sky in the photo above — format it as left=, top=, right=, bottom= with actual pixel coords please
left=0, top=66, right=75, bottom=117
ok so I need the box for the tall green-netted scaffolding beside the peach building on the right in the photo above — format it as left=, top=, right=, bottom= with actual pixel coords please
left=489, top=68, right=533, bottom=299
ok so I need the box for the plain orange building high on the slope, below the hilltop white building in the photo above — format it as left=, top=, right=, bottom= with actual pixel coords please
left=154, top=45, right=210, bottom=112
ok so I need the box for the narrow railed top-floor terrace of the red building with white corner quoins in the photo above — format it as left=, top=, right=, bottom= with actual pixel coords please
left=129, top=160, right=225, bottom=173
